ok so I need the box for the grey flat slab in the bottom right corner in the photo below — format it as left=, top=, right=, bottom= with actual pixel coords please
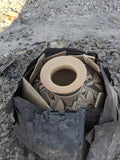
left=86, top=122, right=120, bottom=160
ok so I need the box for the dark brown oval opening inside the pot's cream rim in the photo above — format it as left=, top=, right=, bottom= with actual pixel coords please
left=51, top=69, right=77, bottom=86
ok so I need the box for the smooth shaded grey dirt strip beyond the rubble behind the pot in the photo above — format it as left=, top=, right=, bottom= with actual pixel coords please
left=0, top=0, right=120, bottom=55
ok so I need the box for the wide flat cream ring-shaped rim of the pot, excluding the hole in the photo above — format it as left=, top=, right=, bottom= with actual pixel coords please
left=40, top=56, right=87, bottom=95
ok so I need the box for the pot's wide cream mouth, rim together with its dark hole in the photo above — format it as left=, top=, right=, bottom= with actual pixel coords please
left=40, top=56, right=87, bottom=95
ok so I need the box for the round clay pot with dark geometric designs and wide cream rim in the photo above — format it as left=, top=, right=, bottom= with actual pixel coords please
left=33, top=56, right=104, bottom=111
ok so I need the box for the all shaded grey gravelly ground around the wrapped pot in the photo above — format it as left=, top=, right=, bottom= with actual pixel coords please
left=0, top=0, right=120, bottom=160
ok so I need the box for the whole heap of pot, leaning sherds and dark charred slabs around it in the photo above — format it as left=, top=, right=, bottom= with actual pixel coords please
left=6, top=48, right=120, bottom=160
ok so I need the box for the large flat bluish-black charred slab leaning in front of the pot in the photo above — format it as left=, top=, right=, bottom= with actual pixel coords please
left=14, top=97, right=85, bottom=160
